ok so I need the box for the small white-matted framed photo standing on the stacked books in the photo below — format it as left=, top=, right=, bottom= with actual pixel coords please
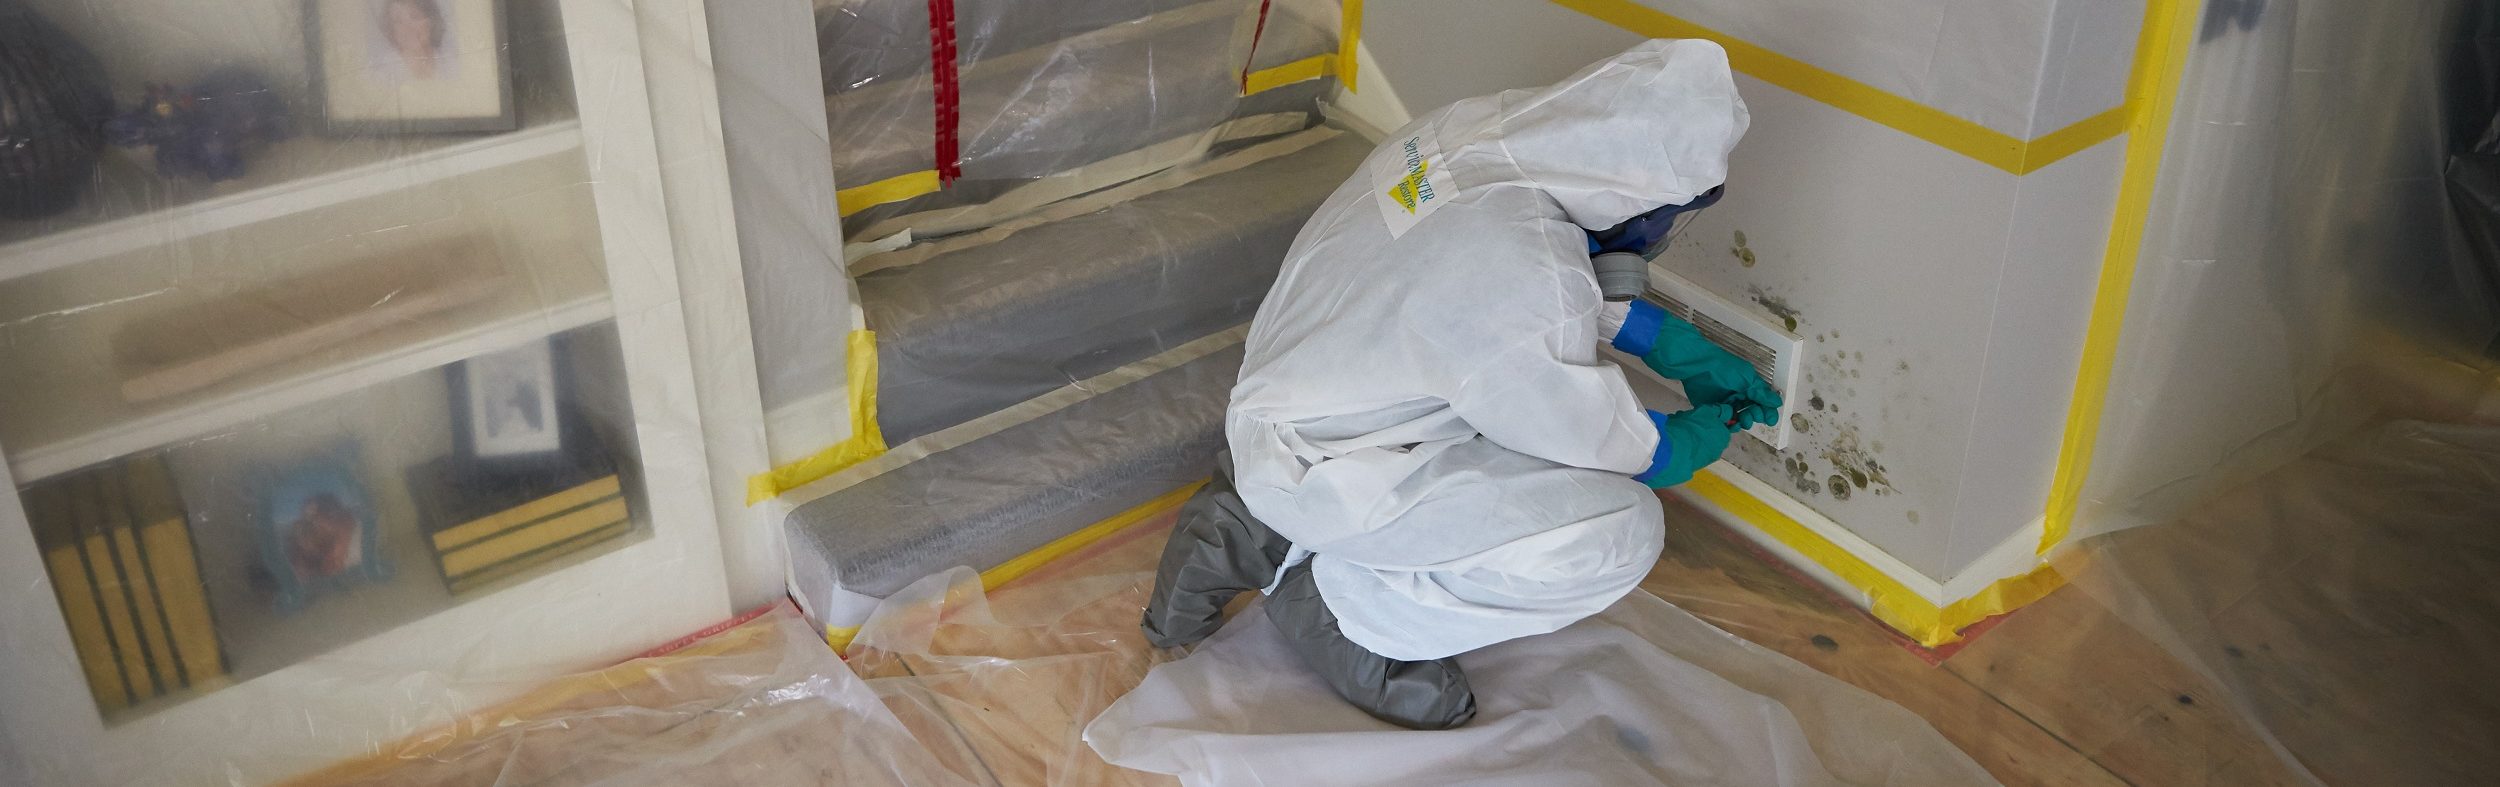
left=450, top=340, right=565, bottom=465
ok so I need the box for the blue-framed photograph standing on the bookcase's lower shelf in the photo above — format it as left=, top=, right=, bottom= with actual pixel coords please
left=258, top=442, right=390, bottom=612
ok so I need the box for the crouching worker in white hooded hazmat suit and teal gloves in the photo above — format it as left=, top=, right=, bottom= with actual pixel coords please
left=1145, top=40, right=1780, bottom=730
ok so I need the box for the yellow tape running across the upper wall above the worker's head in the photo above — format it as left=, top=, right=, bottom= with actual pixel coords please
left=1553, top=0, right=2140, bottom=175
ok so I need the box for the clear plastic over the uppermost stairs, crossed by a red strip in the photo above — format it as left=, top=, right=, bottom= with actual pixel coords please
left=818, top=0, right=1335, bottom=208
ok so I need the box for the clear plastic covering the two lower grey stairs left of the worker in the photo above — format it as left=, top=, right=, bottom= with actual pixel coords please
left=785, top=128, right=1370, bottom=627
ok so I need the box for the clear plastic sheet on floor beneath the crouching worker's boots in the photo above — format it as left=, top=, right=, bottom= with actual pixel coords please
left=1085, top=592, right=1993, bottom=785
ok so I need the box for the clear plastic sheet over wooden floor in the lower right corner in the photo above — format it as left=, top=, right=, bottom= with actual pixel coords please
left=2068, top=420, right=2500, bottom=785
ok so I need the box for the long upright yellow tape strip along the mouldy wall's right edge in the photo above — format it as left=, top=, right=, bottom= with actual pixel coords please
left=2040, top=0, right=2200, bottom=555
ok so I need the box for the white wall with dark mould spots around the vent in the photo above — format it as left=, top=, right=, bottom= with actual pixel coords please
left=1365, top=0, right=2143, bottom=582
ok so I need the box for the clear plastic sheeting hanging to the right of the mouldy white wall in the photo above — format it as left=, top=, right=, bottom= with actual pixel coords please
left=2078, top=0, right=2500, bottom=535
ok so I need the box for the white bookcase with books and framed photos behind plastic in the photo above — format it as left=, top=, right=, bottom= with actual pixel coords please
left=0, top=0, right=763, bottom=785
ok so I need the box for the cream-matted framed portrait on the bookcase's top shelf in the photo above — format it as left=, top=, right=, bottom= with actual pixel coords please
left=305, top=0, right=520, bottom=132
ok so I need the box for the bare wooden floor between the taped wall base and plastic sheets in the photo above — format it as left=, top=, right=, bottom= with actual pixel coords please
left=1643, top=497, right=2303, bottom=785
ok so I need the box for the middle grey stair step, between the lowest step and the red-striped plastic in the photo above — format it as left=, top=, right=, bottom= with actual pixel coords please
left=858, top=135, right=1370, bottom=442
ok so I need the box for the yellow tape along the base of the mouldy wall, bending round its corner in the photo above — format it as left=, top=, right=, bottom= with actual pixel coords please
left=1685, top=470, right=2065, bottom=647
